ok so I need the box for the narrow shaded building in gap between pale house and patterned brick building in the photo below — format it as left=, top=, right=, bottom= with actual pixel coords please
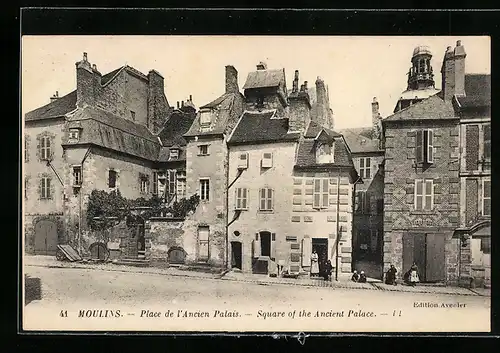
left=339, top=98, right=385, bottom=278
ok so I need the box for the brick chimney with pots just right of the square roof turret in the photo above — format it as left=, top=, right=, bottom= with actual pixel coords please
left=288, top=70, right=311, bottom=133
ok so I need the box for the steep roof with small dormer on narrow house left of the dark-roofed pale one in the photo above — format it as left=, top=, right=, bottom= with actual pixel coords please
left=184, top=92, right=244, bottom=137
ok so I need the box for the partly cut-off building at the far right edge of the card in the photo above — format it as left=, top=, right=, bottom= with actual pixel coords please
left=453, top=69, right=491, bottom=285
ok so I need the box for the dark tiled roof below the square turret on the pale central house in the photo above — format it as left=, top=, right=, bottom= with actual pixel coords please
left=228, top=110, right=300, bottom=144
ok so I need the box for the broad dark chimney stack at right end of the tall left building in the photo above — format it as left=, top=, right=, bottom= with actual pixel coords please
left=147, top=70, right=170, bottom=134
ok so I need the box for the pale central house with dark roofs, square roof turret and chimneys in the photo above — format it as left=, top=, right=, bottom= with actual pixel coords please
left=228, top=63, right=357, bottom=273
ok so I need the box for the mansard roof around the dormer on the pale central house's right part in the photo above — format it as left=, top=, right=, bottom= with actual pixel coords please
left=295, top=135, right=354, bottom=167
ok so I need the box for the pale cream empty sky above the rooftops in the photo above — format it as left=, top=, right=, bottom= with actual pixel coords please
left=21, top=35, right=491, bottom=130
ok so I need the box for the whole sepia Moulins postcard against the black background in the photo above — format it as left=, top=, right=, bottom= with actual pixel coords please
left=21, top=36, right=491, bottom=332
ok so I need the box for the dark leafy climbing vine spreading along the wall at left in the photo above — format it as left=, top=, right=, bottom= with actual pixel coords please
left=87, top=190, right=200, bottom=231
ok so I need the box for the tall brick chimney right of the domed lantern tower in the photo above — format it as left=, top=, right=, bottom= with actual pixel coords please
left=441, top=40, right=467, bottom=100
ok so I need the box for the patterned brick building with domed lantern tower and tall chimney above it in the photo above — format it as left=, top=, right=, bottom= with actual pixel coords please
left=382, top=43, right=465, bottom=283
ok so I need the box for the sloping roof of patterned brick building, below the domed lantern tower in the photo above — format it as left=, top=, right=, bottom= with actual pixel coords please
left=382, top=94, right=456, bottom=123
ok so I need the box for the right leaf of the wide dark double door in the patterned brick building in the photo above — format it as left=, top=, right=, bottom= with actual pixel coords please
left=426, top=233, right=446, bottom=282
